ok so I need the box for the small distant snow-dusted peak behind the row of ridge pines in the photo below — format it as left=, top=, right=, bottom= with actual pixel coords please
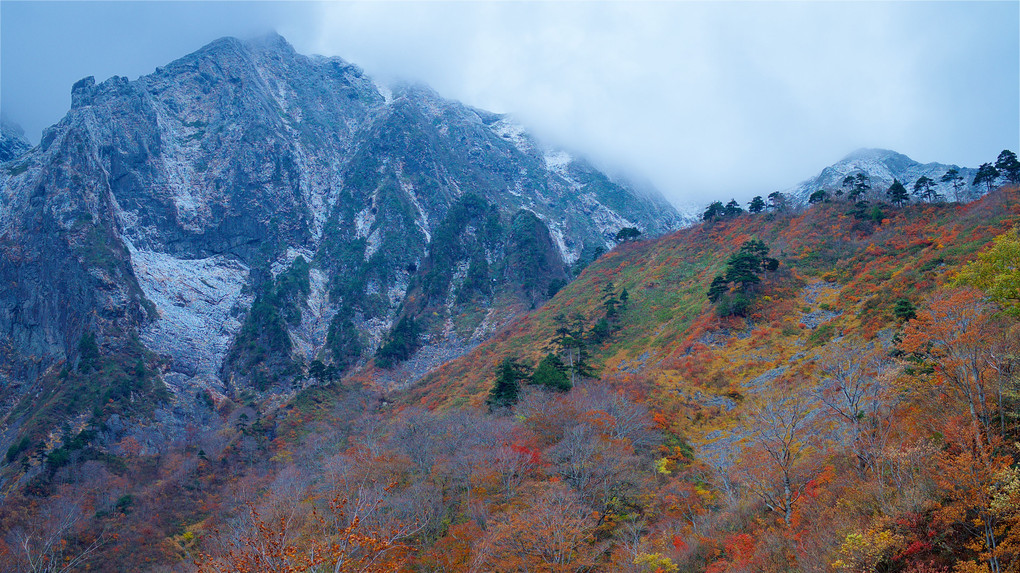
left=783, top=149, right=985, bottom=203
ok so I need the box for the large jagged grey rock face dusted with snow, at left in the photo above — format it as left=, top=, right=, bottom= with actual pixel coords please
left=0, top=36, right=681, bottom=403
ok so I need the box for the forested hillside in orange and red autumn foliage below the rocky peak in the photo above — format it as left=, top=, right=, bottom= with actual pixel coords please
left=0, top=176, right=1020, bottom=573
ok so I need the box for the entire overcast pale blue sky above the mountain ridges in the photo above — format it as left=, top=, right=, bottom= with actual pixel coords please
left=0, top=0, right=1020, bottom=204
